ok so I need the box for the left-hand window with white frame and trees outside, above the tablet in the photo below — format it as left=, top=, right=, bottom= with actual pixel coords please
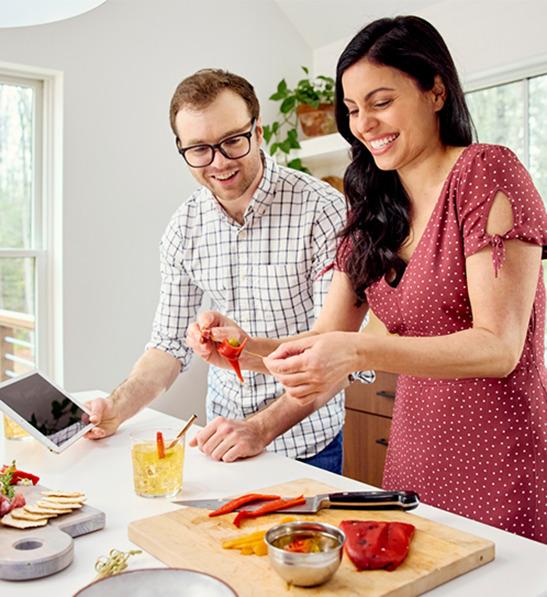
left=0, top=64, right=62, bottom=381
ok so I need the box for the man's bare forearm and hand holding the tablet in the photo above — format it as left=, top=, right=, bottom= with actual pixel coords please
left=86, top=348, right=180, bottom=439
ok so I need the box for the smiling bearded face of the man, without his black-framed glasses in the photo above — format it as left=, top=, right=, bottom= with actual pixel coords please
left=175, top=90, right=262, bottom=207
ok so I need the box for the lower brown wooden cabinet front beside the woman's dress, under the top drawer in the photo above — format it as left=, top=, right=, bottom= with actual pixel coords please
left=344, top=408, right=391, bottom=487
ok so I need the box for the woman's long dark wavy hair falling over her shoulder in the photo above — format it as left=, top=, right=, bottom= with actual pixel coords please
left=336, top=16, right=473, bottom=303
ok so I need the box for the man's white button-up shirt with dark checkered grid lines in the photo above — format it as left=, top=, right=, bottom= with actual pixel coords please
left=147, top=155, right=346, bottom=458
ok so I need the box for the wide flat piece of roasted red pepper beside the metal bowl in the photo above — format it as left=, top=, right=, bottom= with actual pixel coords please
left=340, top=520, right=415, bottom=571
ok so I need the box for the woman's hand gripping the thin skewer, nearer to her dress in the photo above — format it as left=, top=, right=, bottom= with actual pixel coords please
left=264, top=332, right=360, bottom=404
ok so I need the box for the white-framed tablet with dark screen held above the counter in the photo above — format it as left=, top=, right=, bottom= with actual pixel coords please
left=0, top=371, right=94, bottom=452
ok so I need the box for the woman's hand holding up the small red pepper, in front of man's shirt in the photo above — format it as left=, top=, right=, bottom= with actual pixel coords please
left=186, top=311, right=248, bottom=369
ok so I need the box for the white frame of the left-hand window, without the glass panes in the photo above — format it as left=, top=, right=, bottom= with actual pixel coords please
left=0, top=61, right=64, bottom=385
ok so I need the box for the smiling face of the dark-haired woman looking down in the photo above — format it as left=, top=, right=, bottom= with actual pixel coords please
left=342, top=58, right=445, bottom=172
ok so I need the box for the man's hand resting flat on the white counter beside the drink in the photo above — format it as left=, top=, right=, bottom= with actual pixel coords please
left=188, top=417, right=267, bottom=462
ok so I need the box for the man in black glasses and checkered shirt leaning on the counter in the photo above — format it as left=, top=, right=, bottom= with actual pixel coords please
left=88, top=69, right=345, bottom=472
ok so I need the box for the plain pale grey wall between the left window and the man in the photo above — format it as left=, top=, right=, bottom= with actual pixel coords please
left=0, top=0, right=312, bottom=421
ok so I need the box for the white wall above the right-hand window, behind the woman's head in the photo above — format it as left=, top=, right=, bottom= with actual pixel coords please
left=314, top=0, right=547, bottom=84
